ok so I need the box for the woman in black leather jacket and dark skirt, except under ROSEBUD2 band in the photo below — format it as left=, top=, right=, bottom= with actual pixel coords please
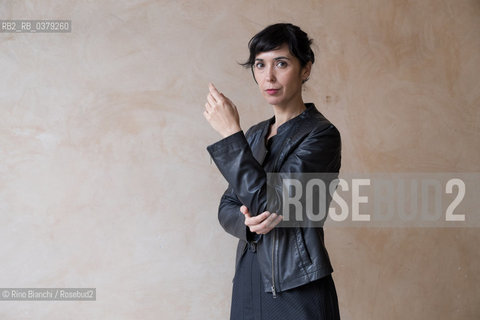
left=204, top=23, right=341, bottom=320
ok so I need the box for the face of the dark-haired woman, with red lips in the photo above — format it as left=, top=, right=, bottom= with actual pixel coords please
left=253, top=44, right=311, bottom=107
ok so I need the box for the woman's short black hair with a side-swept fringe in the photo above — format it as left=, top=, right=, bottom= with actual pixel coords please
left=240, top=23, right=315, bottom=71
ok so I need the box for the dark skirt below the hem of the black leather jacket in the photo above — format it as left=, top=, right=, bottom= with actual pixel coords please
left=230, top=244, right=340, bottom=320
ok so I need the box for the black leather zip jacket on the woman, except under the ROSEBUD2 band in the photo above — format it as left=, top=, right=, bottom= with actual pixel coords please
left=207, top=103, right=341, bottom=295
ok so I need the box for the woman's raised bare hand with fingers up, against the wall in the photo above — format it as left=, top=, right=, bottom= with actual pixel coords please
left=203, top=83, right=242, bottom=138
